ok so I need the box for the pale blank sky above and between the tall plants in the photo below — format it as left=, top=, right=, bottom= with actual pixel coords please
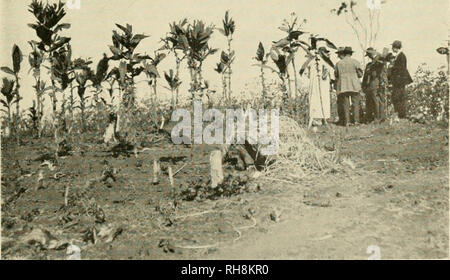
left=0, top=0, right=449, bottom=114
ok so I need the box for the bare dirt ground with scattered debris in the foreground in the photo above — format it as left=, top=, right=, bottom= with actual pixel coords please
left=1, top=121, right=449, bottom=259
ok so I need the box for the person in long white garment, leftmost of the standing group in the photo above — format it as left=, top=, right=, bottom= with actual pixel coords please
left=309, top=47, right=332, bottom=127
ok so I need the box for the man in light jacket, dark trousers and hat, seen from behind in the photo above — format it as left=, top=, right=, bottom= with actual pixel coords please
left=334, top=47, right=362, bottom=126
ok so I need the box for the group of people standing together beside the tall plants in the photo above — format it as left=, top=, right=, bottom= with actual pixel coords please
left=309, top=41, right=412, bottom=126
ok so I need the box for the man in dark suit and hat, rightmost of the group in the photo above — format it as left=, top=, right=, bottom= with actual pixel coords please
left=390, top=41, right=412, bottom=119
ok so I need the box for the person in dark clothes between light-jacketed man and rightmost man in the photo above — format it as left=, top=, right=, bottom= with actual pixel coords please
left=361, top=48, right=386, bottom=122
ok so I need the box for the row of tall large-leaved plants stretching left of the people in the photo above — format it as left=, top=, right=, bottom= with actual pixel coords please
left=1, top=0, right=320, bottom=147
